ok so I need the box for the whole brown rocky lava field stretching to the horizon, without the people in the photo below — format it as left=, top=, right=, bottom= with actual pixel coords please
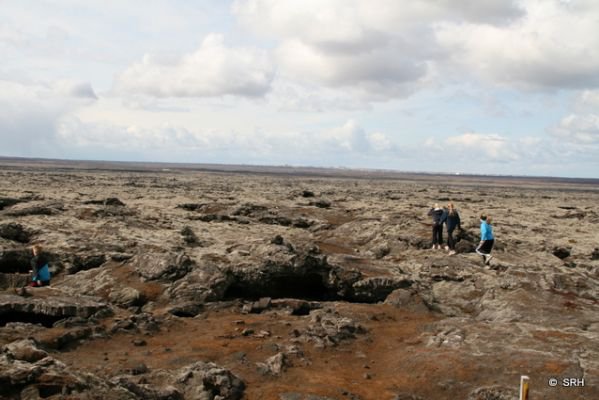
left=0, top=165, right=599, bottom=400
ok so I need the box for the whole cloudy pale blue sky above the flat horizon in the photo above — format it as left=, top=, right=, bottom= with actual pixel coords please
left=0, top=0, right=599, bottom=178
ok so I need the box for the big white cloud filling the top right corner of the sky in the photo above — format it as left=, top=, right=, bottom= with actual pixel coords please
left=436, top=0, right=599, bottom=89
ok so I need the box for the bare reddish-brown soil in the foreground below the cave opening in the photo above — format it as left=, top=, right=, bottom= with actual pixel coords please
left=36, top=303, right=580, bottom=400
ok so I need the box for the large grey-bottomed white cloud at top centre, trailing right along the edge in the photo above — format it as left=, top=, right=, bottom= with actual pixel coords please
left=232, top=0, right=524, bottom=100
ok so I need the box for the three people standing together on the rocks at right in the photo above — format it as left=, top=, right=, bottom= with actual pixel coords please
left=428, top=203, right=495, bottom=265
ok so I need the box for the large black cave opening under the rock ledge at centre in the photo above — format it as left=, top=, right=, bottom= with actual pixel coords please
left=224, top=273, right=339, bottom=301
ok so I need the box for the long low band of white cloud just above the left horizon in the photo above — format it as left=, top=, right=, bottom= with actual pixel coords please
left=56, top=116, right=394, bottom=165
